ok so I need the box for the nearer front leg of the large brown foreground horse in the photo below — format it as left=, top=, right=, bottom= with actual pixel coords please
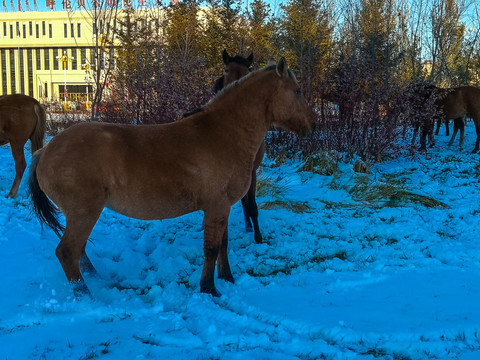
left=200, top=209, right=230, bottom=296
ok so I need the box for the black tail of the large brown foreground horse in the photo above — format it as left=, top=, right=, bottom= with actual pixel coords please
left=28, top=150, right=65, bottom=238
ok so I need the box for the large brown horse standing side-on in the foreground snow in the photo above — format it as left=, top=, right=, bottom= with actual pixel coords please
left=29, top=58, right=315, bottom=295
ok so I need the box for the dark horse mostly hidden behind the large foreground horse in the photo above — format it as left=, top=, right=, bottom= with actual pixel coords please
left=213, top=50, right=265, bottom=244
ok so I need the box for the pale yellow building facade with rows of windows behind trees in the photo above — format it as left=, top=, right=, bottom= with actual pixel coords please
left=0, top=11, right=95, bottom=102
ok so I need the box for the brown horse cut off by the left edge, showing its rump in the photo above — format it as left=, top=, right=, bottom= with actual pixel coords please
left=0, top=94, right=46, bottom=198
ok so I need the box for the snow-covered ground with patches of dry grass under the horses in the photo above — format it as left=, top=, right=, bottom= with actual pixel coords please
left=0, top=124, right=480, bottom=360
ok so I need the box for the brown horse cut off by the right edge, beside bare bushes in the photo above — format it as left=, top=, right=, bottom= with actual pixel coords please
left=422, top=86, right=480, bottom=153
